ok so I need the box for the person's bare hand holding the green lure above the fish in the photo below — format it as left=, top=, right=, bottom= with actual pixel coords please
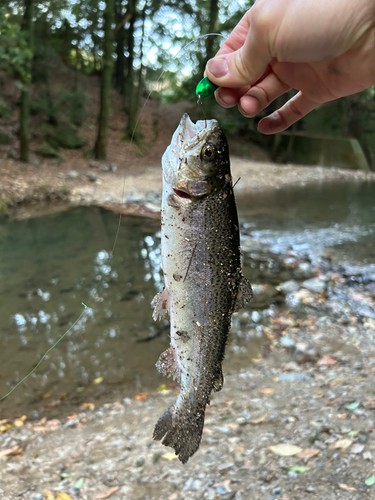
left=205, top=0, right=375, bottom=134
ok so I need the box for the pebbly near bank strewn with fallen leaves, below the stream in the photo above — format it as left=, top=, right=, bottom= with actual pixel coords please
left=0, top=214, right=375, bottom=500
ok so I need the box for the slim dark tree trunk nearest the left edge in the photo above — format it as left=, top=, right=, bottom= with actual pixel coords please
left=19, top=0, right=34, bottom=162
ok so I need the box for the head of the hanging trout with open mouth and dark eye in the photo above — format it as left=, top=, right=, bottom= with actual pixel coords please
left=162, top=113, right=231, bottom=199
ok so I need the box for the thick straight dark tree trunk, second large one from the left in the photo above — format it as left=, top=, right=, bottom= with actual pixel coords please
left=94, top=0, right=114, bottom=160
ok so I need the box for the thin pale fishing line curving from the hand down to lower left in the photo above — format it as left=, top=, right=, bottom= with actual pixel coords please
left=0, top=33, right=225, bottom=401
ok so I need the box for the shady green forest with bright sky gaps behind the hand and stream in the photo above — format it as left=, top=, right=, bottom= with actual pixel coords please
left=0, top=0, right=375, bottom=170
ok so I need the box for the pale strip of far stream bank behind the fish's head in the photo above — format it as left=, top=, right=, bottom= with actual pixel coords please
left=0, top=157, right=375, bottom=217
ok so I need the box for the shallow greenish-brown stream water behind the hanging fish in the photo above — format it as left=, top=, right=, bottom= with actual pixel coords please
left=0, top=183, right=375, bottom=419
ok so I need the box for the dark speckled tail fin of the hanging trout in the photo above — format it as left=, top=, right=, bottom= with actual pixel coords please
left=153, top=399, right=206, bottom=464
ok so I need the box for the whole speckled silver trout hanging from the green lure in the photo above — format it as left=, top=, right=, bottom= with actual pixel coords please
left=152, top=114, right=252, bottom=463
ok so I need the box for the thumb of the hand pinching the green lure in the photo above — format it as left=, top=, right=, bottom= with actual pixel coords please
left=206, top=9, right=272, bottom=88
